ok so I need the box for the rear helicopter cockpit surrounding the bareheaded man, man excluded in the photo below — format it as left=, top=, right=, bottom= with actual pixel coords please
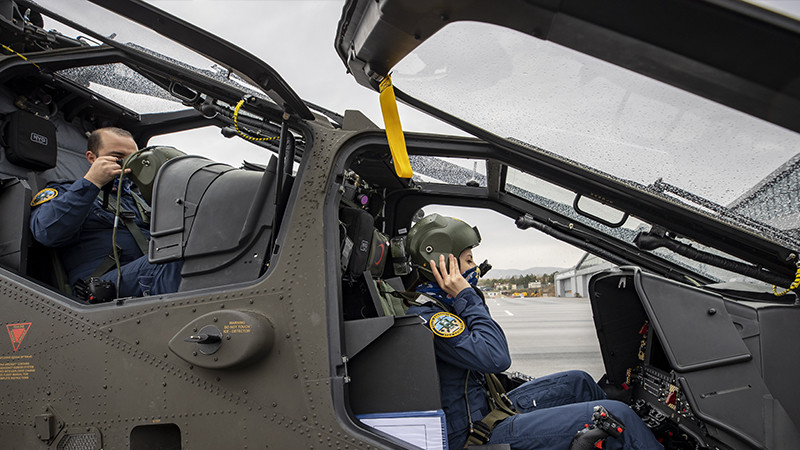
left=0, top=2, right=313, bottom=298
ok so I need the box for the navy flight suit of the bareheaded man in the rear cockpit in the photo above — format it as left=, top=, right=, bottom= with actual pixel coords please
left=30, top=178, right=183, bottom=297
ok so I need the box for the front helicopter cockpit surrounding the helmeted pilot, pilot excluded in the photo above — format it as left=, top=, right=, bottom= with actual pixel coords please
left=324, top=111, right=798, bottom=448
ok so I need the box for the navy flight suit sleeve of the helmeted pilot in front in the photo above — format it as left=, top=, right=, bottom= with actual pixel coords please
left=429, top=289, right=511, bottom=373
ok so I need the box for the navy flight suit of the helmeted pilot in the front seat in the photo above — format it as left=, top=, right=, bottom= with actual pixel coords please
left=408, top=289, right=663, bottom=450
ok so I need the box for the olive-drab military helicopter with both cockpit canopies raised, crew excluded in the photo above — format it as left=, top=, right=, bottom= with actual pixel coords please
left=0, top=0, right=800, bottom=450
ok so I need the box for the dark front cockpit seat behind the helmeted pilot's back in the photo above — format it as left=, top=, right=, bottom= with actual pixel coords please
left=339, top=206, right=442, bottom=416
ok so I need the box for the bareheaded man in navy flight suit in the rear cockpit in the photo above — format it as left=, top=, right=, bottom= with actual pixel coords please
left=30, top=127, right=181, bottom=302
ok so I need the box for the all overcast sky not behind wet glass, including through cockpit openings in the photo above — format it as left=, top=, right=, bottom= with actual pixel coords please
left=138, top=0, right=583, bottom=269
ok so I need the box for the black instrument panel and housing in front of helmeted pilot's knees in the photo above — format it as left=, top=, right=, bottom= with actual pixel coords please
left=589, top=267, right=800, bottom=449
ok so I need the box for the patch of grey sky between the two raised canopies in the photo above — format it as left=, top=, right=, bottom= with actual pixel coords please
left=149, top=0, right=452, bottom=132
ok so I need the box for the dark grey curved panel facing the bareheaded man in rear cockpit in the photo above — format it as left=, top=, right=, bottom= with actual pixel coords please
left=148, top=155, right=277, bottom=291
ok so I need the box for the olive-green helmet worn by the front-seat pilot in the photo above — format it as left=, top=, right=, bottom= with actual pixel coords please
left=406, top=214, right=481, bottom=281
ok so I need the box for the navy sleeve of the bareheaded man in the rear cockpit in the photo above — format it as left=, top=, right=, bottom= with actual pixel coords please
left=30, top=178, right=100, bottom=247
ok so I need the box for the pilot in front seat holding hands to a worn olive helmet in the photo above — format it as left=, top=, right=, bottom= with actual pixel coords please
left=406, top=214, right=662, bottom=450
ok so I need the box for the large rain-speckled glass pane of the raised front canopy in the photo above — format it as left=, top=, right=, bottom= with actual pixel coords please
left=392, top=22, right=800, bottom=243
